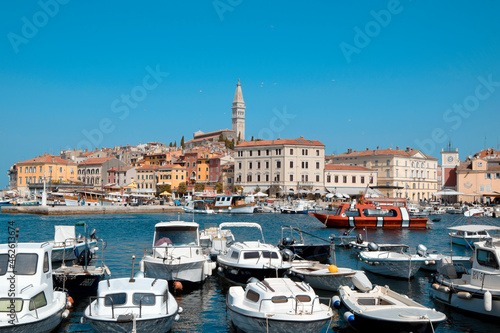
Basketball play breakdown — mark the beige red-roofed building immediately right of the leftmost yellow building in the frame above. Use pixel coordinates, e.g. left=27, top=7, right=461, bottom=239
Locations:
left=78, top=157, right=126, bottom=188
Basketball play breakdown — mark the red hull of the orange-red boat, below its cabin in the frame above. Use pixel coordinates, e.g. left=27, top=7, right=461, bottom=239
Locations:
left=309, top=213, right=428, bottom=229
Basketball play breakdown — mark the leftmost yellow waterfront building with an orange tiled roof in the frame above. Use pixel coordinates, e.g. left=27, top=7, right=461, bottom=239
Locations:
left=17, top=154, right=77, bottom=195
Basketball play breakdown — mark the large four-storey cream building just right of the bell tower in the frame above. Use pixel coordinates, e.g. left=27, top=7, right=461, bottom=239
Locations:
left=234, top=137, right=325, bottom=194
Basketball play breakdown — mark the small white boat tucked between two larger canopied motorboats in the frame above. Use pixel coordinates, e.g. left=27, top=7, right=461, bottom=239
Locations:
left=200, top=222, right=237, bottom=260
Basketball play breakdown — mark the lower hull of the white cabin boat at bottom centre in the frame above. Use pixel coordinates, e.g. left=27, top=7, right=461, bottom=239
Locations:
left=229, top=307, right=329, bottom=333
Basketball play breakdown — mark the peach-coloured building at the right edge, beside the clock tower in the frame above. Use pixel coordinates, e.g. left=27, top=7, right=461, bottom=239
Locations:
left=456, top=158, right=500, bottom=203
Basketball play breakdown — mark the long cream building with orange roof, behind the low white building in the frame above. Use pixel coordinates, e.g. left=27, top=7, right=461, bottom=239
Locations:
left=330, top=147, right=438, bottom=202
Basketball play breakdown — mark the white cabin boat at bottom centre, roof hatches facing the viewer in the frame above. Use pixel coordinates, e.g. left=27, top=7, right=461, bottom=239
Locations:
left=226, top=278, right=333, bottom=333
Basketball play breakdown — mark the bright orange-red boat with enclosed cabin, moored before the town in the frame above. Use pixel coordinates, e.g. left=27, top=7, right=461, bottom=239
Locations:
left=309, top=198, right=428, bottom=229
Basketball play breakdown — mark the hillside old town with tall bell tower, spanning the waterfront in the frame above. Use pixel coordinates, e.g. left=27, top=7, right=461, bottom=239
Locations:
left=0, top=80, right=500, bottom=204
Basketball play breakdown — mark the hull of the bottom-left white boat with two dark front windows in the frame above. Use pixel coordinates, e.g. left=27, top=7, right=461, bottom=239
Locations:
left=85, top=313, right=177, bottom=333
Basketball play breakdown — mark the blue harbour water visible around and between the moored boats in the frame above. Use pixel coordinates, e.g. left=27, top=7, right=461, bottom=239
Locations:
left=0, top=210, right=500, bottom=333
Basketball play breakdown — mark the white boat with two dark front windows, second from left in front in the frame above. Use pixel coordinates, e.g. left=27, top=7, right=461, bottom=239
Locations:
left=82, top=278, right=182, bottom=333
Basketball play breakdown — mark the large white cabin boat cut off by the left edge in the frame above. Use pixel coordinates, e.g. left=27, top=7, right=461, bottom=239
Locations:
left=0, top=242, right=69, bottom=333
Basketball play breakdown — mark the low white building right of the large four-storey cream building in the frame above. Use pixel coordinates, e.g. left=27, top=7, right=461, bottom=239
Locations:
left=324, top=164, right=382, bottom=197
